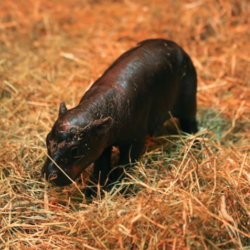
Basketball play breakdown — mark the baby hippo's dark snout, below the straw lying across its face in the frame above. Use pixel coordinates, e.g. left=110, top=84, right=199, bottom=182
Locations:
left=41, top=158, right=72, bottom=186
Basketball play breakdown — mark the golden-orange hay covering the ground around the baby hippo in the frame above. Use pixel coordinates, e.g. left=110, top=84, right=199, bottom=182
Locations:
left=0, top=0, right=250, bottom=249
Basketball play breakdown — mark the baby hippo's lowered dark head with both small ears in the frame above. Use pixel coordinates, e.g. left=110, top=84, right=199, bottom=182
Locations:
left=42, top=102, right=112, bottom=186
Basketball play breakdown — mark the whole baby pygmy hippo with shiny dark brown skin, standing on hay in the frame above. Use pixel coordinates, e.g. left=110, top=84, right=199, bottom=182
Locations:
left=42, top=39, right=197, bottom=195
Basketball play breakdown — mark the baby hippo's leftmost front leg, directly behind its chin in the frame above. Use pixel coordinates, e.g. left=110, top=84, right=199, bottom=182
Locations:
left=85, top=146, right=112, bottom=197
